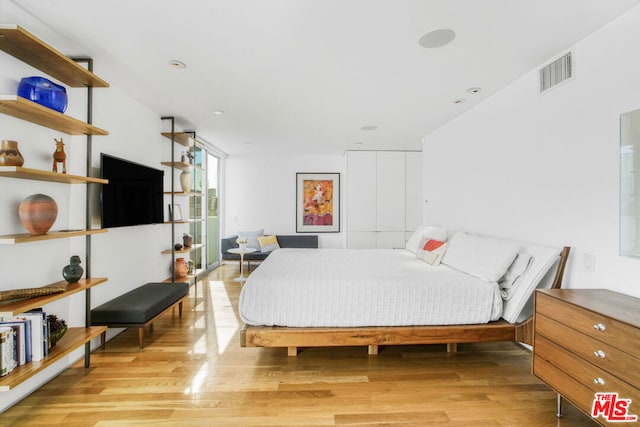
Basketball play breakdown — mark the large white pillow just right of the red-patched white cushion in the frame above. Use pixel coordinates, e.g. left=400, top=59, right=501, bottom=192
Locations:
left=442, top=232, right=518, bottom=282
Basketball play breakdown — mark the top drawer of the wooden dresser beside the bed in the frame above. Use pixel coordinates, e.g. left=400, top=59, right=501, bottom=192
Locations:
left=536, top=292, right=640, bottom=359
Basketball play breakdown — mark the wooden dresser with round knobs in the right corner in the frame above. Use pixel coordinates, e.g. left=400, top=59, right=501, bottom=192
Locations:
left=533, top=289, right=640, bottom=425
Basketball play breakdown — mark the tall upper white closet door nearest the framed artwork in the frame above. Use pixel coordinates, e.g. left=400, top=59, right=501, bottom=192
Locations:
left=346, top=151, right=376, bottom=231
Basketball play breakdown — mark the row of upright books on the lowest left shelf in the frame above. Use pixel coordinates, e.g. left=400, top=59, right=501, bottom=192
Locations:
left=0, top=309, right=51, bottom=376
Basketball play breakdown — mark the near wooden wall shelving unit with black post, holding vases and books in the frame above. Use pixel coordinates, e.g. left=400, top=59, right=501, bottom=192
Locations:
left=0, top=25, right=109, bottom=391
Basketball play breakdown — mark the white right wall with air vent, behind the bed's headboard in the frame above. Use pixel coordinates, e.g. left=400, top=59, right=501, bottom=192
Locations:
left=423, top=7, right=640, bottom=296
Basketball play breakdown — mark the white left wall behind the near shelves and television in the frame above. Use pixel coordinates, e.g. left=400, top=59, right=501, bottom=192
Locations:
left=0, top=10, right=171, bottom=412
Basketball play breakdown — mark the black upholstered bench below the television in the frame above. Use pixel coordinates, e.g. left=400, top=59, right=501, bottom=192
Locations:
left=91, top=282, right=189, bottom=349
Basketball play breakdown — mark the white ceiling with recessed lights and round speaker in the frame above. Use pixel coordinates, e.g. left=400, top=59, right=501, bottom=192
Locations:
left=0, top=0, right=640, bottom=155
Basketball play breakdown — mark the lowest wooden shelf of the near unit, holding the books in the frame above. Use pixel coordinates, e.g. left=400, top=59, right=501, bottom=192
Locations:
left=0, top=326, right=107, bottom=391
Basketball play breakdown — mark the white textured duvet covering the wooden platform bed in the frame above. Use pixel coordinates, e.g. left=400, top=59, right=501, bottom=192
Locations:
left=239, top=249, right=502, bottom=327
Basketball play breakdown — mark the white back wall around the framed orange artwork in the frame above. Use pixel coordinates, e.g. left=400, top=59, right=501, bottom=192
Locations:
left=221, top=156, right=346, bottom=248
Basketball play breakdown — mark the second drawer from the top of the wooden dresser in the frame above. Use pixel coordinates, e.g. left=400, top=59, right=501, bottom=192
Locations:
left=534, top=313, right=640, bottom=387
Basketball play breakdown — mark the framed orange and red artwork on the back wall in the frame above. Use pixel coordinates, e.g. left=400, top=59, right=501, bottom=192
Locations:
left=296, top=173, right=340, bottom=233
